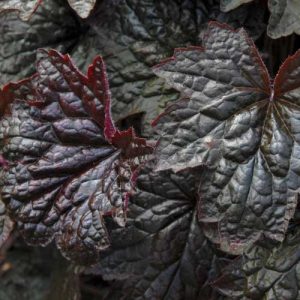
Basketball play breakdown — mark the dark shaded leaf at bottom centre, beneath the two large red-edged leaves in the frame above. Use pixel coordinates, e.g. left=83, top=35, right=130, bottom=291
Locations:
left=90, top=165, right=226, bottom=300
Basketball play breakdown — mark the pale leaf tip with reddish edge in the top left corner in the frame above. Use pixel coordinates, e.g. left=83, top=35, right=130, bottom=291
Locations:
left=0, top=0, right=42, bottom=21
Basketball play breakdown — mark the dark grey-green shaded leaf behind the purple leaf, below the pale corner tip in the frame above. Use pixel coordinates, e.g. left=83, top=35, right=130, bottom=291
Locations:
left=0, top=0, right=80, bottom=85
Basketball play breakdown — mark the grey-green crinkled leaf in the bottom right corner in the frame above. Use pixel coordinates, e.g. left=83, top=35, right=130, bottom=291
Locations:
left=215, top=229, right=300, bottom=300
